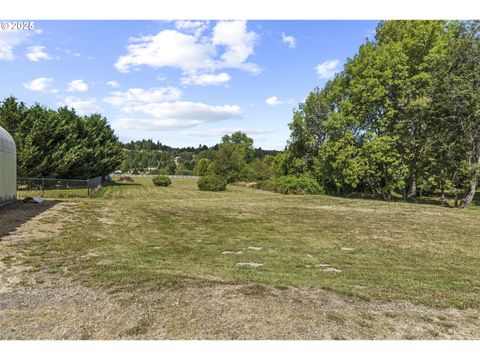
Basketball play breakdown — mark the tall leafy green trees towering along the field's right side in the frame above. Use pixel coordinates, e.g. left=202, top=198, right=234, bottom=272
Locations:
left=282, top=21, right=480, bottom=207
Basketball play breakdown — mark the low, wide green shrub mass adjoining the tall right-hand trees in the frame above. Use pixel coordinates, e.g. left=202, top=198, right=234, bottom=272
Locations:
left=256, top=175, right=325, bottom=195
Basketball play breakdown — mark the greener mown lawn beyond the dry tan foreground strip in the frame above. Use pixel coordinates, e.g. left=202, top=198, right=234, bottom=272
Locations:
left=24, top=179, right=480, bottom=308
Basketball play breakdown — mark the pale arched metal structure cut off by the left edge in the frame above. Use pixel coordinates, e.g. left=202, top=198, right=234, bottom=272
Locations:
left=0, top=126, right=17, bottom=206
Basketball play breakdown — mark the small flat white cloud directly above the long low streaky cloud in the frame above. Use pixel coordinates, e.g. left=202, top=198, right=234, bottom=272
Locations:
left=104, top=86, right=182, bottom=106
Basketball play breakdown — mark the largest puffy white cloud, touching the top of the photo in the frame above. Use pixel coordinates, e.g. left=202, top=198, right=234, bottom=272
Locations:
left=114, top=21, right=261, bottom=74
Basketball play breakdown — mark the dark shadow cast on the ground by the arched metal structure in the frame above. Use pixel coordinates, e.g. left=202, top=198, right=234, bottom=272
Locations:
left=0, top=200, right=60, bottom=241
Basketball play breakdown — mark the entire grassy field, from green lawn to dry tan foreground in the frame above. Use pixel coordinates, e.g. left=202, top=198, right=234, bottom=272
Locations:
left=0, top=180, right=480, bottom=339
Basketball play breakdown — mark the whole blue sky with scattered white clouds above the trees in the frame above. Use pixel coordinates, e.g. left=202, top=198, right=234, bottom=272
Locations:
left=0, top=20, right=377, bottom=149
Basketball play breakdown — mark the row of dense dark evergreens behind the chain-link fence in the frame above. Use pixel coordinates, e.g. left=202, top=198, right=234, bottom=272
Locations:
left=0, top=96, right=123, bottom=179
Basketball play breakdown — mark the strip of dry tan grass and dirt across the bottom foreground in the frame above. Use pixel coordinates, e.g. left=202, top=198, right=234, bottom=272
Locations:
left=0, top=277, right=480, bottom=339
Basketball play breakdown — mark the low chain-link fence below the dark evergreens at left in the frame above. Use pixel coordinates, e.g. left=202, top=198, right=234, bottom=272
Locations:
left=17, top=176, right=103, bottom=198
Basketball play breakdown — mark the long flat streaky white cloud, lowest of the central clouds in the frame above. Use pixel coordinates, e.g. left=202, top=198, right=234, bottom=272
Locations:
left=117, top=101, right=242, bottom=130
